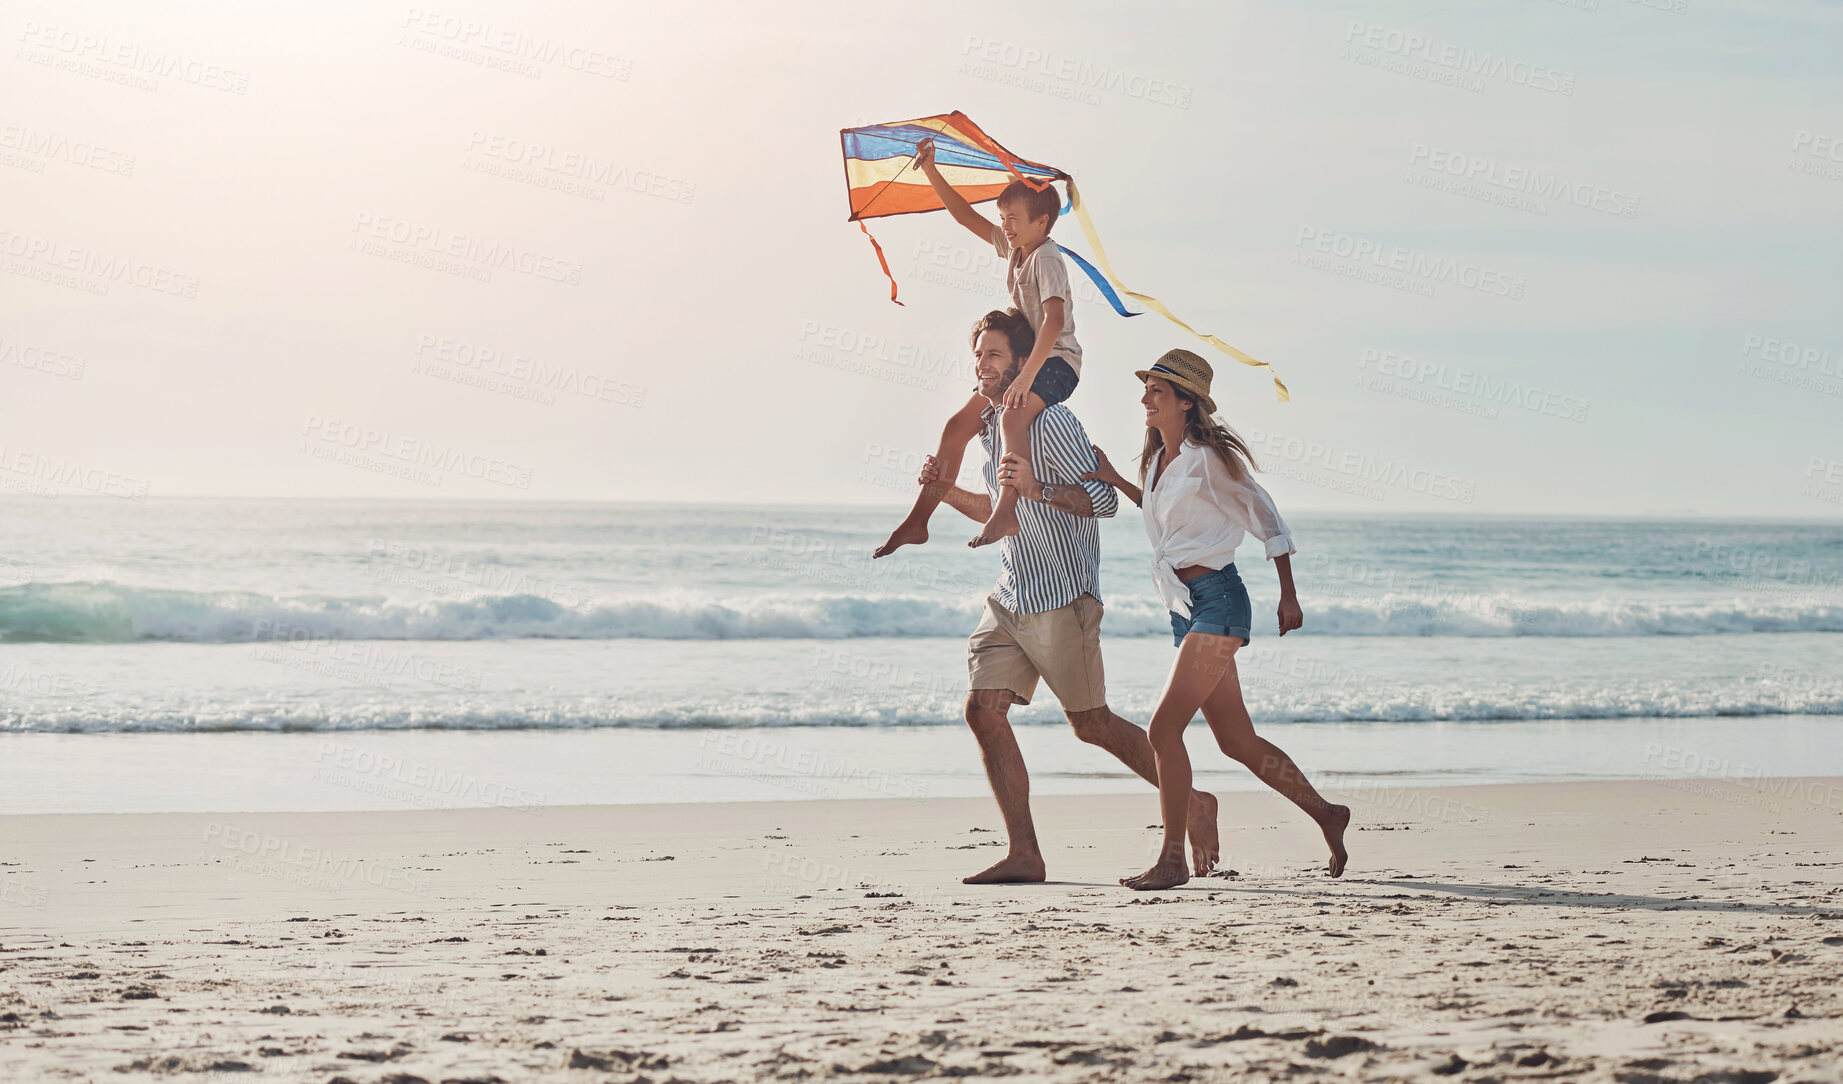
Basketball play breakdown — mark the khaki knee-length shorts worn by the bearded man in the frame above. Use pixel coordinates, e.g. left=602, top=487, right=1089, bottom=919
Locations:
left=966, top=595, right=1108, bottom=712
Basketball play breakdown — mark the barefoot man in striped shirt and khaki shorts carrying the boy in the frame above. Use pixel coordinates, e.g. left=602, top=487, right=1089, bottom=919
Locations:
left=918, top=310, right=1220, bottom=885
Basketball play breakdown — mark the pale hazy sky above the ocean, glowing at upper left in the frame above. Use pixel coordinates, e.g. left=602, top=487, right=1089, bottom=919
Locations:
left=0, top=0, right=1843, bottom=518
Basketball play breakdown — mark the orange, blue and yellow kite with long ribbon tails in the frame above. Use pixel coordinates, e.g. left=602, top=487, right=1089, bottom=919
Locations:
left=839, top=112, right=1290, bottom=402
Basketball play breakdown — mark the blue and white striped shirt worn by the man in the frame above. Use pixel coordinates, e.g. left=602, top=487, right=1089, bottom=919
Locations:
left=979, top=402, right=1121, bottom=614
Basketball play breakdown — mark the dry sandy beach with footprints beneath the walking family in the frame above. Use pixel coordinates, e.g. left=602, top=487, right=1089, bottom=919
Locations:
left=0, top=778, right=1843, bottom=1084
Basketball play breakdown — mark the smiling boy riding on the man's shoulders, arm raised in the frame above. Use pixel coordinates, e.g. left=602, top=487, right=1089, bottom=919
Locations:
left=872, top=140, right=1082, bottom=557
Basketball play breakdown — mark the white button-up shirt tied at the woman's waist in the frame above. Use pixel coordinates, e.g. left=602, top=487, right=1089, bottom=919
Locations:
left=1143, top=441, right=1296, bottom=618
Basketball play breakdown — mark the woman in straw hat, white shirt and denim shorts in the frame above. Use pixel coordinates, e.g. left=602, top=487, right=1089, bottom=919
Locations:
left=1087, top=350, right=1351, bottom=890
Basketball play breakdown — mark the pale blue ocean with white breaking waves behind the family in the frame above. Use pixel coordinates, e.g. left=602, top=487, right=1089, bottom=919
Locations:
left=0, top=500, right=1843, bottom=813
